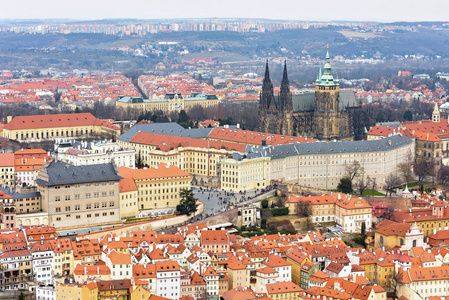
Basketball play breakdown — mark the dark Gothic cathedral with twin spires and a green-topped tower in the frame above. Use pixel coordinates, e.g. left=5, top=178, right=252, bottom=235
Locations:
left=258, top=49, right=360, bottom=141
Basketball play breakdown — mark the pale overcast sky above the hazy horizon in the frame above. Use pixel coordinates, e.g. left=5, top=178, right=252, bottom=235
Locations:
left=0, top=0, right=449, bottom=22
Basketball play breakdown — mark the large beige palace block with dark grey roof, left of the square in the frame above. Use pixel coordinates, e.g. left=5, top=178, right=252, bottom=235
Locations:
left=36, top=161, right=122, bottom=229
